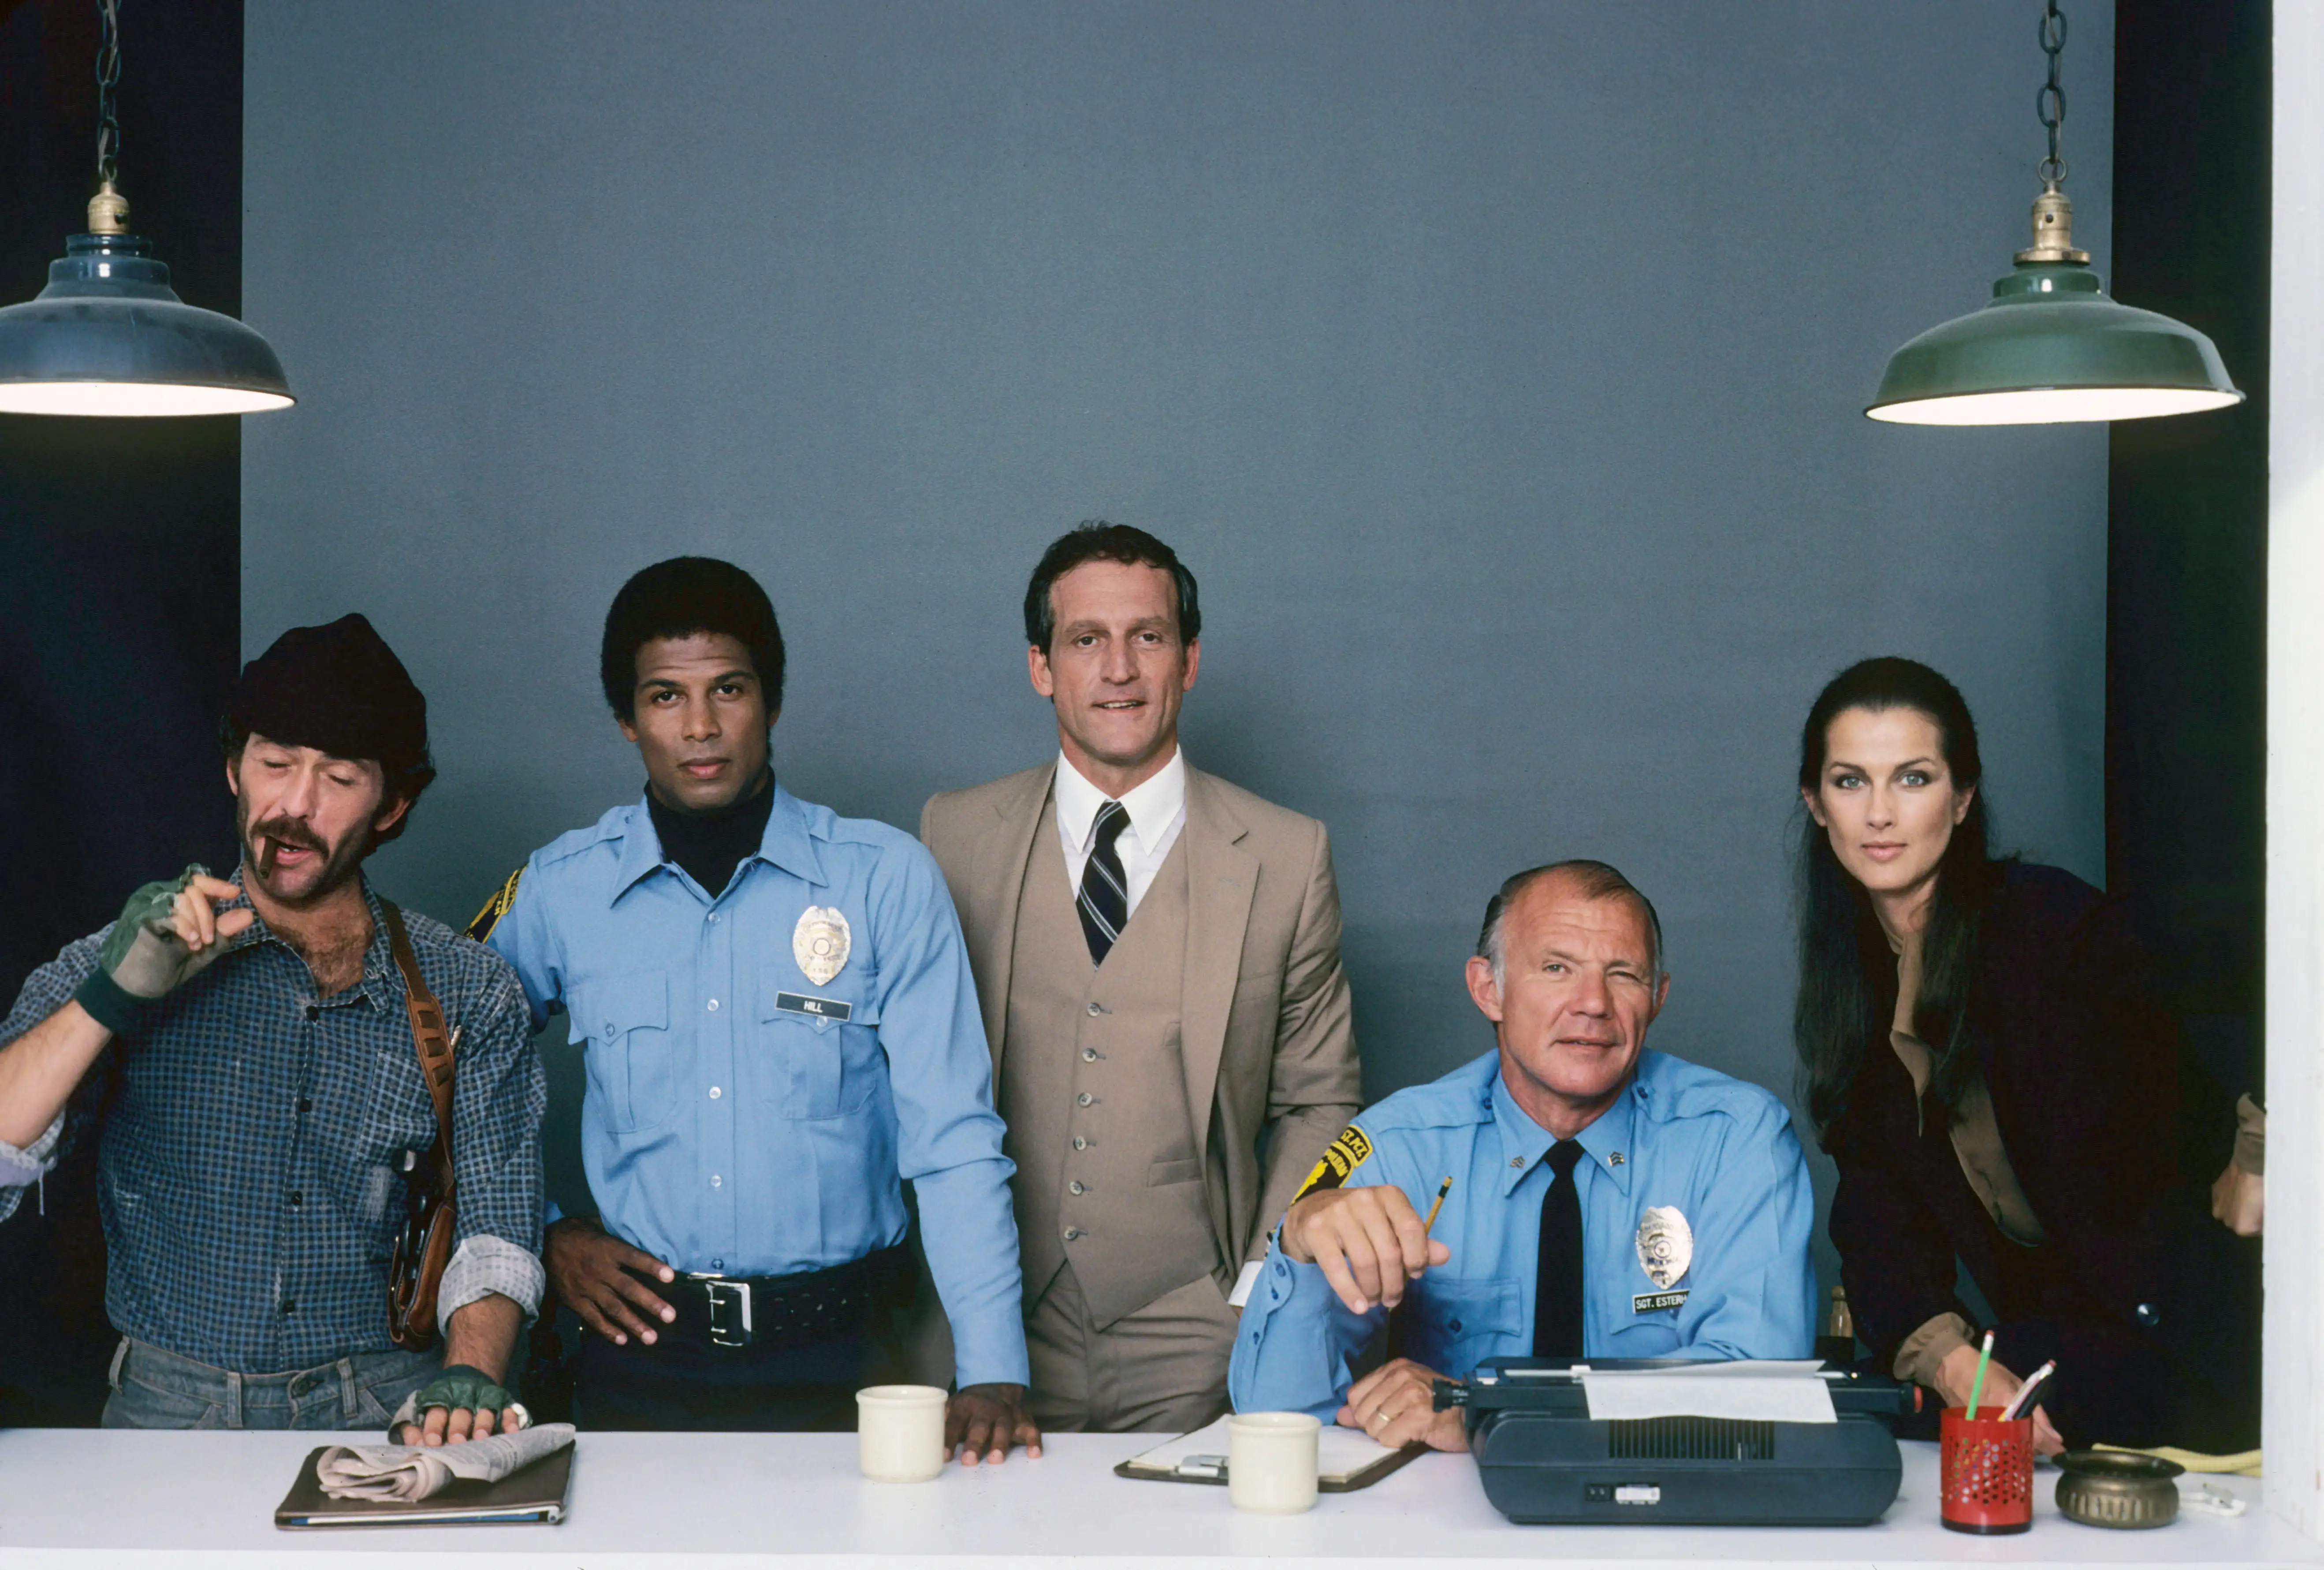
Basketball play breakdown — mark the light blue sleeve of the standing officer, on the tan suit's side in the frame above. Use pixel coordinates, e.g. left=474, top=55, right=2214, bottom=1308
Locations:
left=872, top=843, right=1029, bottom=1384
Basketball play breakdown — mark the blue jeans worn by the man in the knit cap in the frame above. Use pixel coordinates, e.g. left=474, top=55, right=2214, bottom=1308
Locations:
left=102, top=1336, right=444, bottom=1435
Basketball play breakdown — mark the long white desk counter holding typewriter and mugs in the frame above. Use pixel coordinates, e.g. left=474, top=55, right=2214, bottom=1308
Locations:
left=0, top=1429, right=2324, bottom=1570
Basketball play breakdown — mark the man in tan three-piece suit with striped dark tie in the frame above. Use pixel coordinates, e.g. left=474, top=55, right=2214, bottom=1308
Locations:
left=920, top=523, right=1362, bottom=1431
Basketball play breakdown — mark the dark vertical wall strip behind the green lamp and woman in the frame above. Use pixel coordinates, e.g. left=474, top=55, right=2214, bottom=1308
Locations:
left=2105, top=0, right=2273, bottom=1110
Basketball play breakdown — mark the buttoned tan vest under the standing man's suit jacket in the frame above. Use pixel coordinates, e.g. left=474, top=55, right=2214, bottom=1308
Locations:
left=999, top=804, right=1218, bottom=1326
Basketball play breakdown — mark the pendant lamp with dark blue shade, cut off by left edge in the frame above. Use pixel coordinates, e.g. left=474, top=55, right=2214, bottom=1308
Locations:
left=0, top=0, right=293, bottom=416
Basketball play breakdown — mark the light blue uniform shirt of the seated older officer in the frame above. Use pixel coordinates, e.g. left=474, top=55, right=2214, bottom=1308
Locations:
left=1227, top=1050, right=1815, bottom=1421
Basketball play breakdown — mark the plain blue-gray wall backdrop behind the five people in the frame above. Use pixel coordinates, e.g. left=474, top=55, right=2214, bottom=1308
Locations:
left=242, top=0, right=2112, bottom=1273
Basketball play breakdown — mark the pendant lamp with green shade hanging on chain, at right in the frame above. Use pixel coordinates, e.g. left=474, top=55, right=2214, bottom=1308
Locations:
left=1864, top=0, right=2242, bottom=425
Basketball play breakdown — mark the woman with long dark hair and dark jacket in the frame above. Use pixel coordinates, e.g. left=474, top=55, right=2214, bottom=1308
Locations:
left=1794, top=659, right=2257, bottom=1454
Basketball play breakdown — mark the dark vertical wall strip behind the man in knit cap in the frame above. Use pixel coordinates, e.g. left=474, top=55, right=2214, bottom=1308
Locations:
left=0, top=0, right=242, bottom=1424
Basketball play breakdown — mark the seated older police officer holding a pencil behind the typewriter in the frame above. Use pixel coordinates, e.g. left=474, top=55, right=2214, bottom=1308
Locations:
left=1227, top=862, right=1815, bottom=1449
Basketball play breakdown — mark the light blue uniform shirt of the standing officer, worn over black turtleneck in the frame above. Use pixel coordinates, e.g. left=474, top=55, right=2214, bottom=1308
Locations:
left=490, top=785, right=1027, bottom=1384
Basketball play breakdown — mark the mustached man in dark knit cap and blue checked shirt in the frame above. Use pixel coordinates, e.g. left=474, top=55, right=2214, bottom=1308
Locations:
left=0, top=615, right=544, bottom=1444
